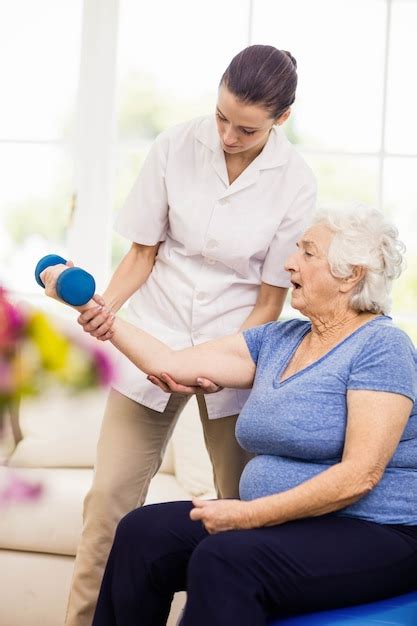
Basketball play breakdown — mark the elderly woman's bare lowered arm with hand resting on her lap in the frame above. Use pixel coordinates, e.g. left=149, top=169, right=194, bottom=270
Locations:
left=191, top=390, right=412, bottom=532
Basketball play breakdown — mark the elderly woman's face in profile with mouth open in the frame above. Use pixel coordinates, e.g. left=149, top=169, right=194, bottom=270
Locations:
left=285, top=224, right=341, bottom=317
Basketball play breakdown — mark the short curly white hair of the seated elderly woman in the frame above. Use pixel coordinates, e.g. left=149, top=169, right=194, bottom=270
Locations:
left=312, top=206, right=405, bottom=314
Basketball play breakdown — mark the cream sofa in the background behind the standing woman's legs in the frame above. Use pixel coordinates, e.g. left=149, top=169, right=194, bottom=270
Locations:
left=0, top=310, right=215, bottom=626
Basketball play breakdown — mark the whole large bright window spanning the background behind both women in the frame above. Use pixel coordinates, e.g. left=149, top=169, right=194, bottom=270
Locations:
left=0, top=0, right=417, bottom=340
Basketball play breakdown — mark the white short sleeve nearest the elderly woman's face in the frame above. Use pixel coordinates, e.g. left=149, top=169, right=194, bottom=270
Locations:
left=262, top=173, right=317, bottom=287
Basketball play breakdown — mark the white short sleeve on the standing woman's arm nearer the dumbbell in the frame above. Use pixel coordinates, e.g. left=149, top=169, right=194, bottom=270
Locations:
left=114, top=133, right=168, bottom=246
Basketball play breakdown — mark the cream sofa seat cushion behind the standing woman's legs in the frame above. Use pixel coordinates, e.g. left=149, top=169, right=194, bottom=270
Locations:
left=0, top=468, right=190, bottom=555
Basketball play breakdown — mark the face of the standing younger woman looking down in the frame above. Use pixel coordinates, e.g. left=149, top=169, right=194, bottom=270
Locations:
left=216, top=85, right=282, bottom=154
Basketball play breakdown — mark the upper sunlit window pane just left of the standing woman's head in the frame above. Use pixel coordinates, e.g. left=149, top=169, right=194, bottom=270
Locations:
left=117, top=0, right=249, bottom=139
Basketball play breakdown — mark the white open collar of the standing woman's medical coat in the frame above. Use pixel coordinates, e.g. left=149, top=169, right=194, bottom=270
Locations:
left=195, top=115, right=291, bottom=197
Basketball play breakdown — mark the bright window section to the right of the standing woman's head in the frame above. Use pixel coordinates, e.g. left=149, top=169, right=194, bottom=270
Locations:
left=251, top=0, right=417, bottom=340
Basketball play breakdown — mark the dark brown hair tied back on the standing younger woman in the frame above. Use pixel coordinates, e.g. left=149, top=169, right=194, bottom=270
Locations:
left=220, top=45, right=297, bottom=119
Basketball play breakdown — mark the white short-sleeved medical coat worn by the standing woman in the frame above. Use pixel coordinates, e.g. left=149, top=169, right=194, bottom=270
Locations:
left=114, top=115, right=316, bottom=419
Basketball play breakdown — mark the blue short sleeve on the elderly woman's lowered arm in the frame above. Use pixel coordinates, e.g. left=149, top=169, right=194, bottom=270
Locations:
left=347, top=326, right=417, bottom=402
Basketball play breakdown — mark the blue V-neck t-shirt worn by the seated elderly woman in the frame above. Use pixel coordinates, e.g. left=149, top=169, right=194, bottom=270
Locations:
left=236, top=316, right=417, bottom=525
